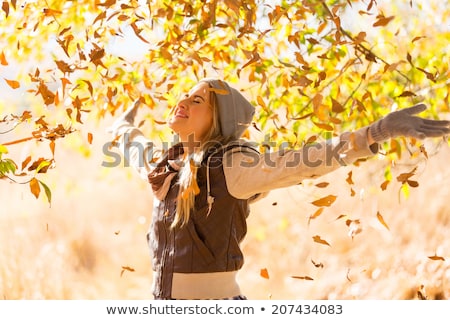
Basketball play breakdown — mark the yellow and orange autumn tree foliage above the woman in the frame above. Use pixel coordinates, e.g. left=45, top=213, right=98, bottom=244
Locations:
left=0, top=0, right=450, bottom=201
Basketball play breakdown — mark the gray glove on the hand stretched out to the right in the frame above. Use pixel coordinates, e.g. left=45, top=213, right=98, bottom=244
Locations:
left=369, top=103, right=450, bottom=142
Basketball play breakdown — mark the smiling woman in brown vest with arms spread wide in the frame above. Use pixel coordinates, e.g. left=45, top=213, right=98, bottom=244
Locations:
left=108, top=79, right=450, bottom=299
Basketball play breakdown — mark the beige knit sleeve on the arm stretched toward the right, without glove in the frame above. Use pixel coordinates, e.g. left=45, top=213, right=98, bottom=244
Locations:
left=224, top=128, right=378, bottom=199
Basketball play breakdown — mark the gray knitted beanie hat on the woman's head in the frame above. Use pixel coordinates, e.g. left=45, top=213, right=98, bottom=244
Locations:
left=201, top=78, right=255, bottom=139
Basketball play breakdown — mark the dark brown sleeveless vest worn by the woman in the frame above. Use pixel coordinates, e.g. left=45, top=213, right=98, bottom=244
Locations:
left=147, top=145, right=256, bottom=299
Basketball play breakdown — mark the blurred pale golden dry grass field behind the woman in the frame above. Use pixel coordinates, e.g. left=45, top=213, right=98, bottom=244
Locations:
left=0, top=118, right=450, bottom=300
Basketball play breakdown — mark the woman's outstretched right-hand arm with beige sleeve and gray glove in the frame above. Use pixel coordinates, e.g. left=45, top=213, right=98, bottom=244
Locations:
left=224, top=104, right=450, bottom=199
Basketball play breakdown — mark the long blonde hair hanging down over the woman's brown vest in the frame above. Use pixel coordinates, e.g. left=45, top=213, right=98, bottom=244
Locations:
left=172, top=85, right=227, bottom=228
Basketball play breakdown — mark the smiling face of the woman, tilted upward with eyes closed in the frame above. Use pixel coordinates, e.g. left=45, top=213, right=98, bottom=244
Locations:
left=168, top=82, right=213, bottom=142
